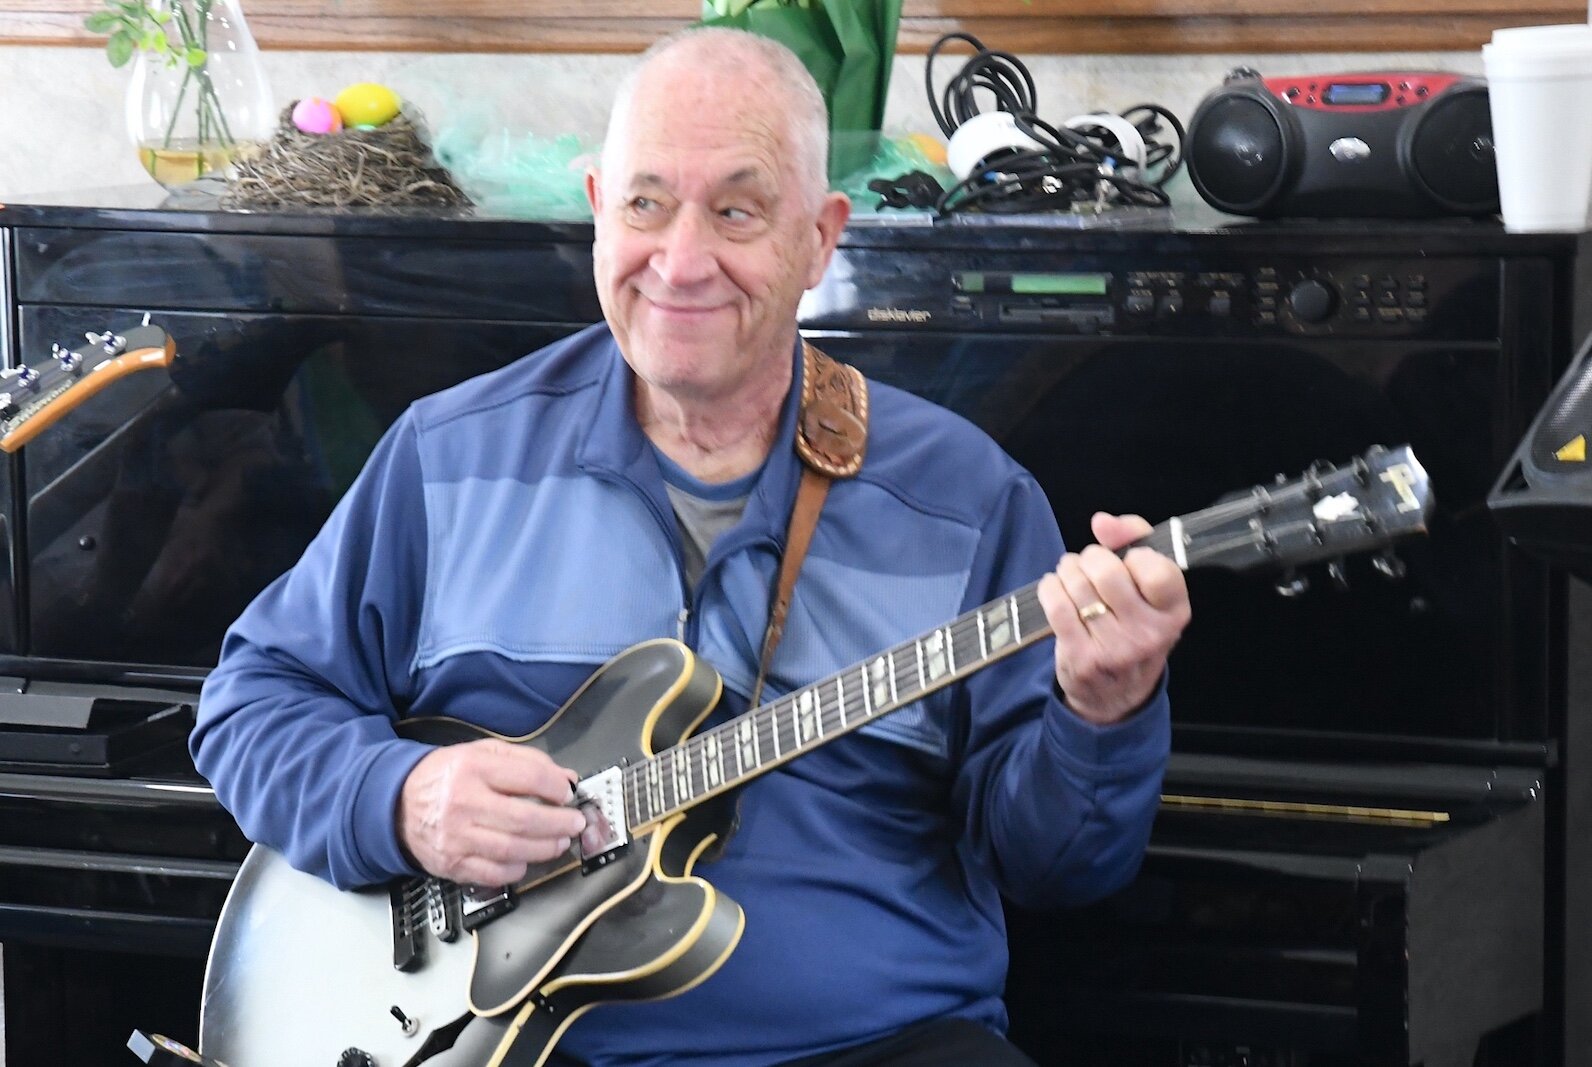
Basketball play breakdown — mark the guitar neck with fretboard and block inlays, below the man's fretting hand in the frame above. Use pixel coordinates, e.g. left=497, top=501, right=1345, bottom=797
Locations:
left=624, top=519, right=1188, bottom=827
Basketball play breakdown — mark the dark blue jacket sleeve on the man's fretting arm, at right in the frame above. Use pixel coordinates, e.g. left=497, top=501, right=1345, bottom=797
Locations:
left=952, top=475, right=1172, bottom=908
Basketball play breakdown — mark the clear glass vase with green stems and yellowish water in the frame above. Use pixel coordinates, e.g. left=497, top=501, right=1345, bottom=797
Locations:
left=127, top=0, right=277, bottom=188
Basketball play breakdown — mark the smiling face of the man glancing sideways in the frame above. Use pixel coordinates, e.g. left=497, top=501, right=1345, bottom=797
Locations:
left=586, top=61, right=849, bottom=400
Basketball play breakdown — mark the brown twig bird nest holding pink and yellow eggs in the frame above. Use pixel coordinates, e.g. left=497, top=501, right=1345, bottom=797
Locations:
left=221, top=102, right=470, bottom=207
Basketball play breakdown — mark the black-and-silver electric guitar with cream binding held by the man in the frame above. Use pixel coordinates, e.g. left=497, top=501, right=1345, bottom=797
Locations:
left=201, top=448, right=1431, bottom=1067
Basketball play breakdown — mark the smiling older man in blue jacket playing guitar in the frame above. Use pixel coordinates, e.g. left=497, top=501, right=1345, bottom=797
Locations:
left=193, top=30, right=1189, bottom=1065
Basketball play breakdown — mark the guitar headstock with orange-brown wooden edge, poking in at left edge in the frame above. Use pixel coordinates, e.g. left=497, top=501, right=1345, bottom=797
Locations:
left=0, top=322, right=177, bottom=452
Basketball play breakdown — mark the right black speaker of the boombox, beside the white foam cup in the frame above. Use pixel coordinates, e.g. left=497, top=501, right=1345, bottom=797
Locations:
left=1409, top=86, right=1498, bottom=215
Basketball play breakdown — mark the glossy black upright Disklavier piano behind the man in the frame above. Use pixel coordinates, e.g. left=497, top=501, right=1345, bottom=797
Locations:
left=0, top=186, right=1592, bottom=1067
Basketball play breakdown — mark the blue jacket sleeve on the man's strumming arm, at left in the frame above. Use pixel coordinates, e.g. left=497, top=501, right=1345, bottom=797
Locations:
left=189, top=416, right=428, bottom=889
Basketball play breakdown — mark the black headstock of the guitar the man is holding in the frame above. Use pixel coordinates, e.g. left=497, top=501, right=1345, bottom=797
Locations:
left=1153, top=446, right=1433, bottom=570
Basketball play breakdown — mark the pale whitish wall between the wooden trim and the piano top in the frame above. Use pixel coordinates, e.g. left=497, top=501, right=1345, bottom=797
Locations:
left=0, top=46, right=1481, bottom=208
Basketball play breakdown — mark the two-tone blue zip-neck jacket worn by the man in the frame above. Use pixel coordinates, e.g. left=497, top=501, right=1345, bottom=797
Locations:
left=193, top=326, right=1170, bottom=1067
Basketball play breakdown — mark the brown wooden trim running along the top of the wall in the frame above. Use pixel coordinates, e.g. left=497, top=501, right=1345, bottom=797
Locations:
left=0, top=0, right=1586, bottom=54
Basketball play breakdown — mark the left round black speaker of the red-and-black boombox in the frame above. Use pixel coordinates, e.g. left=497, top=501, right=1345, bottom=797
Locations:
left=1189, top=96, right=1285, bottom=212
